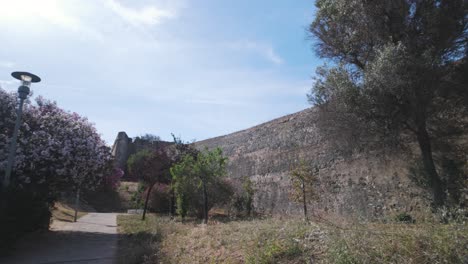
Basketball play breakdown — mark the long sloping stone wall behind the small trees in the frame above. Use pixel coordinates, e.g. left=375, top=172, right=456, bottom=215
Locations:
left=195, top=109, right=428, bottom=219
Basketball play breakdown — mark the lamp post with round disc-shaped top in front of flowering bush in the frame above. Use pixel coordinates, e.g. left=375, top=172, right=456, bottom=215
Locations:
left=3, top=72, right=41, bottom=189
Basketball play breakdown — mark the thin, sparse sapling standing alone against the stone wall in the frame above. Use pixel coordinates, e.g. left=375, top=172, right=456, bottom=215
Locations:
left=289, top=160, right=318, bottom=221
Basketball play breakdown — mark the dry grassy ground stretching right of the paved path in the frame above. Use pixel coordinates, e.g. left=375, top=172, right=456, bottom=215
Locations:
left=117, top=214, right=468, bottom=263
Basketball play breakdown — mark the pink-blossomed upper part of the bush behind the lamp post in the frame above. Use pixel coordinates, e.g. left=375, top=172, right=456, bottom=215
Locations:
left=0, top=91, right=111, bottom=191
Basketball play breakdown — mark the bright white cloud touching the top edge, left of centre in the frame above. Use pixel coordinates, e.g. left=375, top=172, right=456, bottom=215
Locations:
left=105, top=0, right=176, bottom=26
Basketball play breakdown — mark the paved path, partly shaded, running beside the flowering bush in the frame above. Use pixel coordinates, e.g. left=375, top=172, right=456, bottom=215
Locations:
left=0, top=213, right=118, bottom=264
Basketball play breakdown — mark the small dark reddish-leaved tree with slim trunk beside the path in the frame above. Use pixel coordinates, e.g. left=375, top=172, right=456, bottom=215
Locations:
left=127, top=149, right=172, bottom=220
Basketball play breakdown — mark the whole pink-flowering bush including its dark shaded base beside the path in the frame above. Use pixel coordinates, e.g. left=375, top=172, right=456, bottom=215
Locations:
left=0, top=88, right=116, bottom=241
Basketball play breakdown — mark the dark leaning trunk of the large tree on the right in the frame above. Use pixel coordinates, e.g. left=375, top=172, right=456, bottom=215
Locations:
left=416, top=125, right=444, bottom=207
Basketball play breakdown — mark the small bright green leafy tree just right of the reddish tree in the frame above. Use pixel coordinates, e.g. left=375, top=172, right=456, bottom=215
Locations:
left=171, top=148, right=230, bottom=224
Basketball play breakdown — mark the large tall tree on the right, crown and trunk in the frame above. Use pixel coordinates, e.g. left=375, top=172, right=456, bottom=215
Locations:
left=308, top=0, right=468, bottom=206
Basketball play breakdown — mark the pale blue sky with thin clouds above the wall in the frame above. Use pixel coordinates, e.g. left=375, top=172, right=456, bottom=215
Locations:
left=0, top=0, right=322, bottom=144
